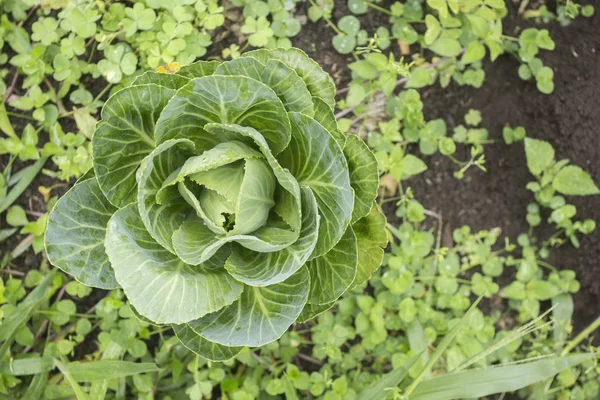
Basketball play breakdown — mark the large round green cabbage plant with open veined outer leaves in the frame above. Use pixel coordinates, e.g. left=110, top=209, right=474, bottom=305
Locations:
left=45, top=49, right=386, bottom=360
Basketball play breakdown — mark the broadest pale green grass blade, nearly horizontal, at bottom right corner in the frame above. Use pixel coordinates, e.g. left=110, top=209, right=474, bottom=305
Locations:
left=409, top=354, right=593, bottom=400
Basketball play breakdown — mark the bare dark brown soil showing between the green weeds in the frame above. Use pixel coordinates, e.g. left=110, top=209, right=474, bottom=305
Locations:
left=0, top=1, right=600, bottom=339
